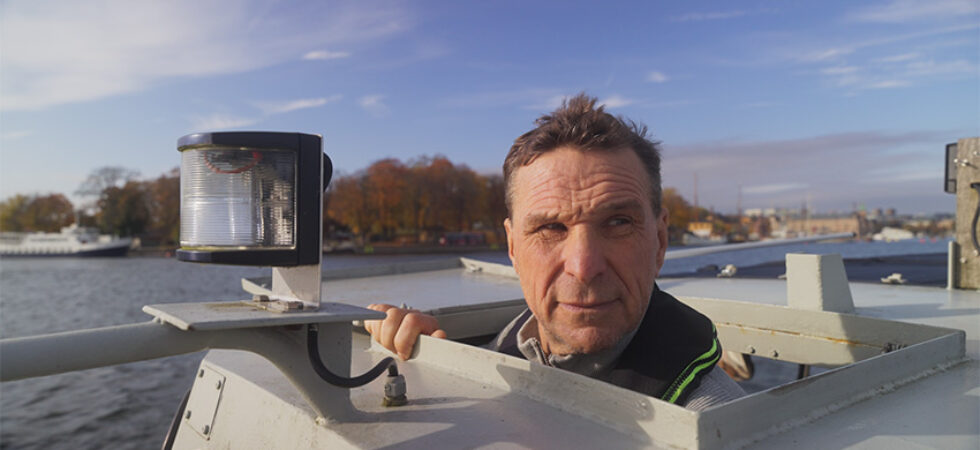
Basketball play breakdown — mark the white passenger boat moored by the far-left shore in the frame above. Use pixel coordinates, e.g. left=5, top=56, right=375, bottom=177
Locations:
left=0, top=224, right=133, bottom=256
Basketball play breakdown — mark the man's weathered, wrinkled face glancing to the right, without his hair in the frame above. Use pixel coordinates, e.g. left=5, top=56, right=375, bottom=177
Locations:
left=504, top=148, right=667, bottom=355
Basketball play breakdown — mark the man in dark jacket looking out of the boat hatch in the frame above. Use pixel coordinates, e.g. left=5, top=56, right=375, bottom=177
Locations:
left=366, top=94, right=743, bottom=410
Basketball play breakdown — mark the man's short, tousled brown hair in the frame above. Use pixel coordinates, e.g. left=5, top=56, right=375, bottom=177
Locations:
left=504, top=93, right=661, bottom=217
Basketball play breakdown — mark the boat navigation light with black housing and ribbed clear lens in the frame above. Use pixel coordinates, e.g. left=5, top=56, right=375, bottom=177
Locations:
left=177, top=132, right=332, bottom=267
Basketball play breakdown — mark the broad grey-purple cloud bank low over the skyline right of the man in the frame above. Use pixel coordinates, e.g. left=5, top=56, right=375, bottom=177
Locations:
left=663, top=130, right=949, bottom=210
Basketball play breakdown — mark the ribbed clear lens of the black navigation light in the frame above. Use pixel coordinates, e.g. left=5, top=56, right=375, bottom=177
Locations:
left=180, top=147, right=296, bottom=248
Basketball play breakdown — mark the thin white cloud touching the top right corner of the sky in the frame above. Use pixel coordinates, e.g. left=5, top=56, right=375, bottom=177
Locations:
left=845, top=0, right=980, bottom=23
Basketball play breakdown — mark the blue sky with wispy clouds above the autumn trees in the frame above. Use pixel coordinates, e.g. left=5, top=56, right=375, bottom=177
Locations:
left=0, top=0, right=980, bottom=214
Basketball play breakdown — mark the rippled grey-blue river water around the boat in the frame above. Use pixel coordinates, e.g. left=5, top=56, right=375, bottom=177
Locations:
left=0, top=241, right=946, bottom=449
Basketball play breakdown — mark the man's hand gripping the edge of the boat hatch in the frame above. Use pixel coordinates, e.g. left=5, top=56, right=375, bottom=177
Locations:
left=364, top=303, right=446, bottom=361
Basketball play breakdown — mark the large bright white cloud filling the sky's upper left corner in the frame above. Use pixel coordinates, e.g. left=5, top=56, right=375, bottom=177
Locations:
left=0, top=0, right=414, bottom=110
